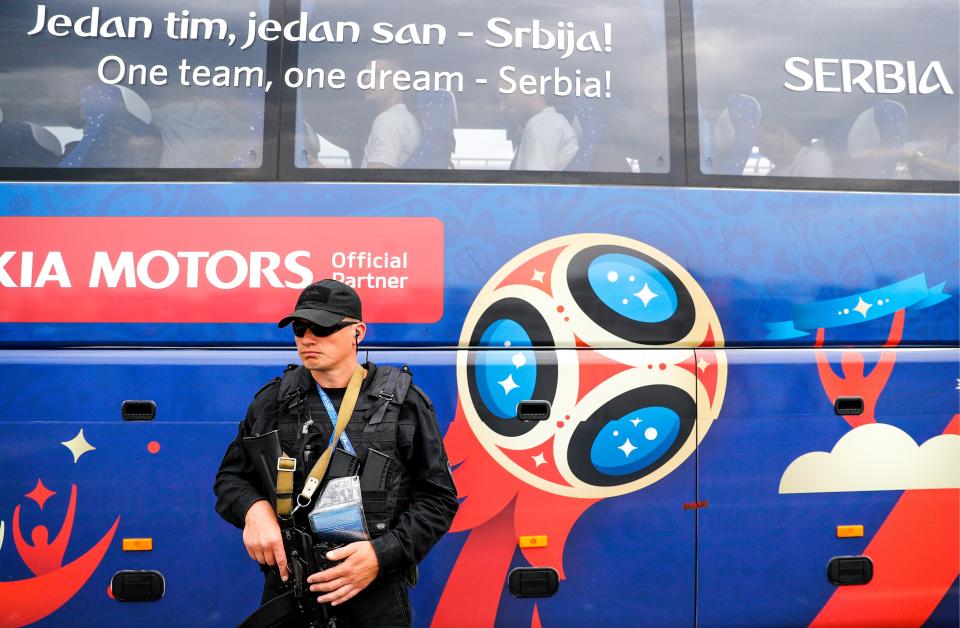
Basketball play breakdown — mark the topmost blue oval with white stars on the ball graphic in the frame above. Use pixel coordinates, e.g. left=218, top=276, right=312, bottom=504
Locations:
left=587, top=253, right=677, bottom=323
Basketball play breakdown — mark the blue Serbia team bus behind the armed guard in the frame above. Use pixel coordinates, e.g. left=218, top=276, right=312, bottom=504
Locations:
left=0, top=0, right=960, bottom=627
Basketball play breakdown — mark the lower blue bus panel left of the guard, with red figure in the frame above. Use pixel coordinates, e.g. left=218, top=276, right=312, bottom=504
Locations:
left=0, top=351, right=295, bottom=626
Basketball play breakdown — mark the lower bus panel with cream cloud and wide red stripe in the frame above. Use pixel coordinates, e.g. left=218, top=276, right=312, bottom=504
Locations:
left=697, top=348, right=960, bottom=626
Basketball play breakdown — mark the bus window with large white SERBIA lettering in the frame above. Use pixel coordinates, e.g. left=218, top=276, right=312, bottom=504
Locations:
left=693, top=0, right=960, bottom=181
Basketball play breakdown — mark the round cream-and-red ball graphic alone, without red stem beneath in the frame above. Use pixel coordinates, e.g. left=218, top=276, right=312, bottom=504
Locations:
left=457, top=234, right=726, bottom=499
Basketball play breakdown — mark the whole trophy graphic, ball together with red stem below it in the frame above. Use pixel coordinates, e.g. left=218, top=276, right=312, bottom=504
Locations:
left=433, top=234, right=727, bottom=626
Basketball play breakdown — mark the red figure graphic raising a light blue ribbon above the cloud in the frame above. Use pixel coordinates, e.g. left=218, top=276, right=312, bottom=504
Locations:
left=814, top=310, right=904, bottom=427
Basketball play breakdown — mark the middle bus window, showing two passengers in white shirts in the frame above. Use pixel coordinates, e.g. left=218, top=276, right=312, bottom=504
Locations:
left=287, top=0, right=670, bottom=173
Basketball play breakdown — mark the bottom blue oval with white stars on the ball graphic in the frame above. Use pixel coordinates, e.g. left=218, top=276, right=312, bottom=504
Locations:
left=590, top=406, right=680, bottom=475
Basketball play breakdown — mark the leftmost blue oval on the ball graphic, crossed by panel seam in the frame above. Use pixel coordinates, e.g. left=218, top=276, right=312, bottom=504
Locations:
left=476, top=319, right=537, bottom=419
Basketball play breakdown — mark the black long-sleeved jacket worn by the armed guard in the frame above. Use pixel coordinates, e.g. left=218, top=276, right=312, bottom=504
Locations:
left=213, top=363, right=459, bottom=575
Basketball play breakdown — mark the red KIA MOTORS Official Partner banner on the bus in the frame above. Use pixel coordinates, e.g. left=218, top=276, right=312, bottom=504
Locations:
left=0, top=217, right=443, bottom=323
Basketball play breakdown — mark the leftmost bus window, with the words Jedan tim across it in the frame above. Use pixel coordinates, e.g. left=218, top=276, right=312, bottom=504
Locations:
left=0, top=0, right=268, bottom=168
